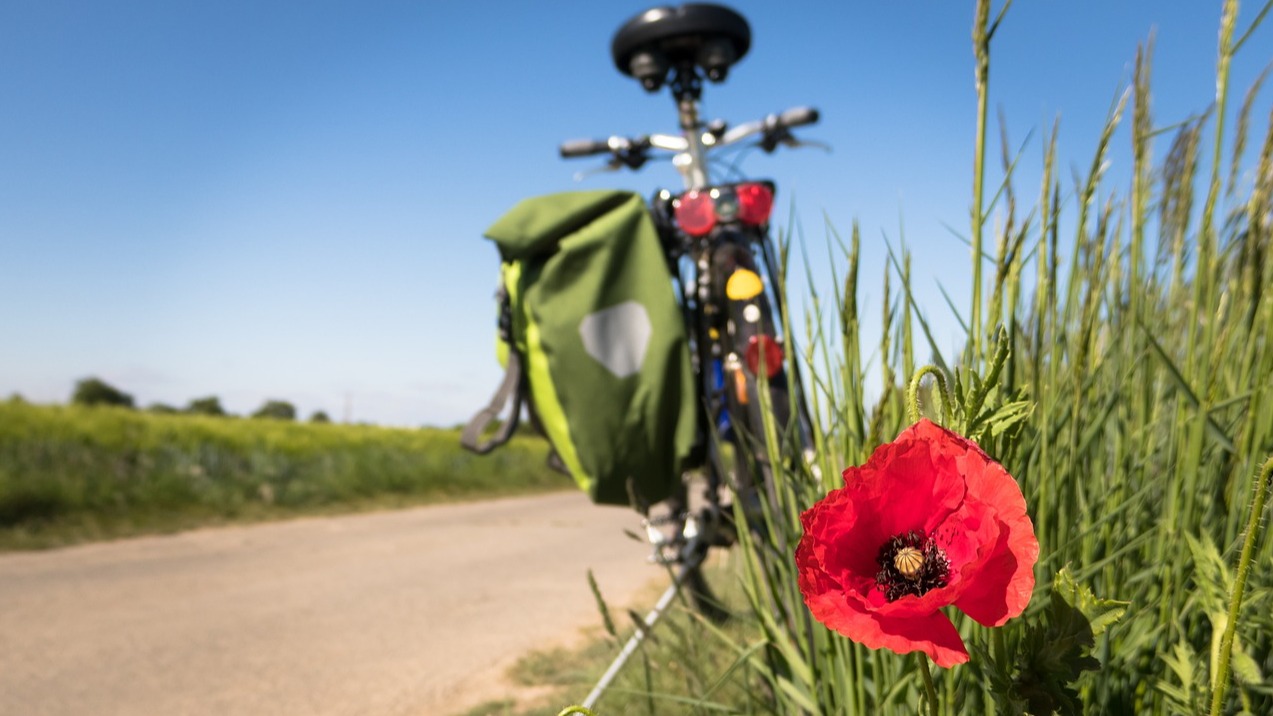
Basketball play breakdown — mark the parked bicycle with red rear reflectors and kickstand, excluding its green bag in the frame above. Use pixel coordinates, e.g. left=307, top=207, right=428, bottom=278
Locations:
left=560, top=4, right=819, bottom=706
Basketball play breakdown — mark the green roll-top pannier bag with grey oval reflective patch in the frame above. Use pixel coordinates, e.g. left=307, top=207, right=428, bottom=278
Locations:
left=462, top=191, right=698, bottom=508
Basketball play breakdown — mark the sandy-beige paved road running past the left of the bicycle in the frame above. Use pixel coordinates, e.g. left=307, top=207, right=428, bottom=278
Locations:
left=0, top=493, right=659, bottom=716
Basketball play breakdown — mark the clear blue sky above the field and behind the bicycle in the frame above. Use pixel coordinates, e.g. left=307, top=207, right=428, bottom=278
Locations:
left=0, top=0, right=1273, bottom=426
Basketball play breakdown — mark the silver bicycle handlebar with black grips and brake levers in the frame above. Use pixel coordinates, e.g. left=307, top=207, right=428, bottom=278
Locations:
left=560, top=107, right=819, bottom=161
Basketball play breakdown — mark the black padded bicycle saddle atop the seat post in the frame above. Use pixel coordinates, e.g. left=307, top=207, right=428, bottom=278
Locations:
left=610, top=3, right=751, bottom=92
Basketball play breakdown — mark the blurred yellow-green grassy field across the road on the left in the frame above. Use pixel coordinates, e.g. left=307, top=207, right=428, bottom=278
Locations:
left=0, top=401, right=572, bottom=549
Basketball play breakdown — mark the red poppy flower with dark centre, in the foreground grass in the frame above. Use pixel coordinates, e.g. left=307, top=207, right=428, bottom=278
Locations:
left=796, top=420, right=1039, bottom=668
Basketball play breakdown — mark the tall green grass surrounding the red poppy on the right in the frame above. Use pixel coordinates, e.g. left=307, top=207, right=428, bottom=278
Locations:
left=598, top=0, right=1273, bottom=713
